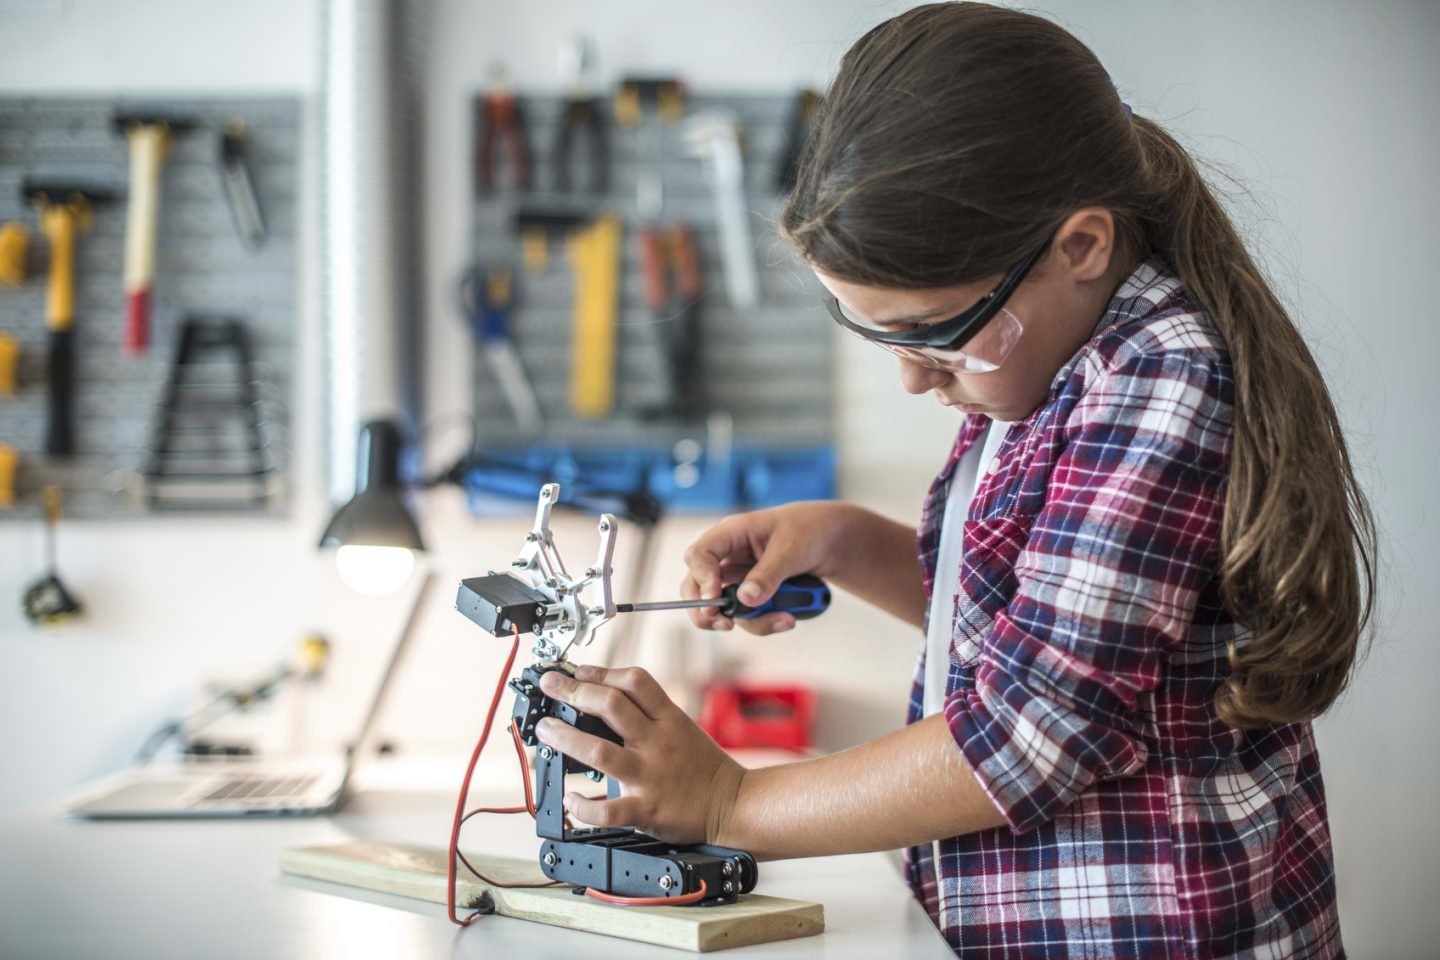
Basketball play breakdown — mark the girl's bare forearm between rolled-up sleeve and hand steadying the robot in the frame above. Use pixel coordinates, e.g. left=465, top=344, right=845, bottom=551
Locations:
left=708, top=715, right=1005, bottom=859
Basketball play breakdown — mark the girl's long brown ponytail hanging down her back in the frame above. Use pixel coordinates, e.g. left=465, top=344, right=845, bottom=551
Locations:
left=1132, top=117, right=1377, bottom=727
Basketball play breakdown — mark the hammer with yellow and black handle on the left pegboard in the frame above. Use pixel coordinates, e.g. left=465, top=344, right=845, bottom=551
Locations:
left=20, top=180, right=114, bottom=456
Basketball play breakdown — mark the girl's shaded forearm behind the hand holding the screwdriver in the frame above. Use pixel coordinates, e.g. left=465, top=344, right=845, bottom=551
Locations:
left=832, top=504, right=924, bottom=626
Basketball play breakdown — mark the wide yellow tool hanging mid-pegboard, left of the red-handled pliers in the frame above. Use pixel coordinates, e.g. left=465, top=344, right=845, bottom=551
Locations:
left=569, top=214, right=622, bottom=419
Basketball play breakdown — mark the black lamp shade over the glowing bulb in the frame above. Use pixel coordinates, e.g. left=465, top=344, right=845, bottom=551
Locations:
left=320, top=420, right=425, bottom=551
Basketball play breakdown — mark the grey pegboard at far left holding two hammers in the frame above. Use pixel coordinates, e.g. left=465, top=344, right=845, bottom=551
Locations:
left=0, top=98, right=300, bottom=520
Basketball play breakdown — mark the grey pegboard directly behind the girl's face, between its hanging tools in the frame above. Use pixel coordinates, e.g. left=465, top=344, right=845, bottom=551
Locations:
left=466, top=94, right=834, bottom=457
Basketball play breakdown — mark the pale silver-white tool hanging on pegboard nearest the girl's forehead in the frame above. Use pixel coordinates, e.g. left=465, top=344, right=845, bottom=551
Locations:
left=685, top=111, right=760, bottom=308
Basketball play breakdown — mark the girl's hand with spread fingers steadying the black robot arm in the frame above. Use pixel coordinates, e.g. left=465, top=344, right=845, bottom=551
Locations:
left=536, top=666, right=744, bottom=843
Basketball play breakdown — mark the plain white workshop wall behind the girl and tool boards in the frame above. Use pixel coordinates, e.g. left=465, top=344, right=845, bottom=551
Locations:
left=0, top=0, right=1440, bottom=957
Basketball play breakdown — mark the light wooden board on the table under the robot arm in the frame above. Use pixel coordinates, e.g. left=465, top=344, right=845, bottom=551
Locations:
left=279, top=843, right=825, bottom=953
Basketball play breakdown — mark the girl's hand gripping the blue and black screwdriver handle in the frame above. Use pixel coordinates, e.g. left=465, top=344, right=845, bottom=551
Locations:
left=680, top=501, right=852, bottom=636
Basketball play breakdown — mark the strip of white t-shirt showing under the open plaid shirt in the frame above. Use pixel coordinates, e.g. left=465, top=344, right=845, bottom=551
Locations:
left=924, top=420, right=1009, bottom=717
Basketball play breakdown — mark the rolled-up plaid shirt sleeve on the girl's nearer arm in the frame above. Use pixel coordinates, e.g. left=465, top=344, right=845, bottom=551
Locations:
left=945, top=350, right=1233, bottom=832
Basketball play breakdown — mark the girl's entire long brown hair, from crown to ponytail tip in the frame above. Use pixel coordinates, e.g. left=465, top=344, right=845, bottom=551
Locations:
left=780, top=3, right=1377, bottom=727
